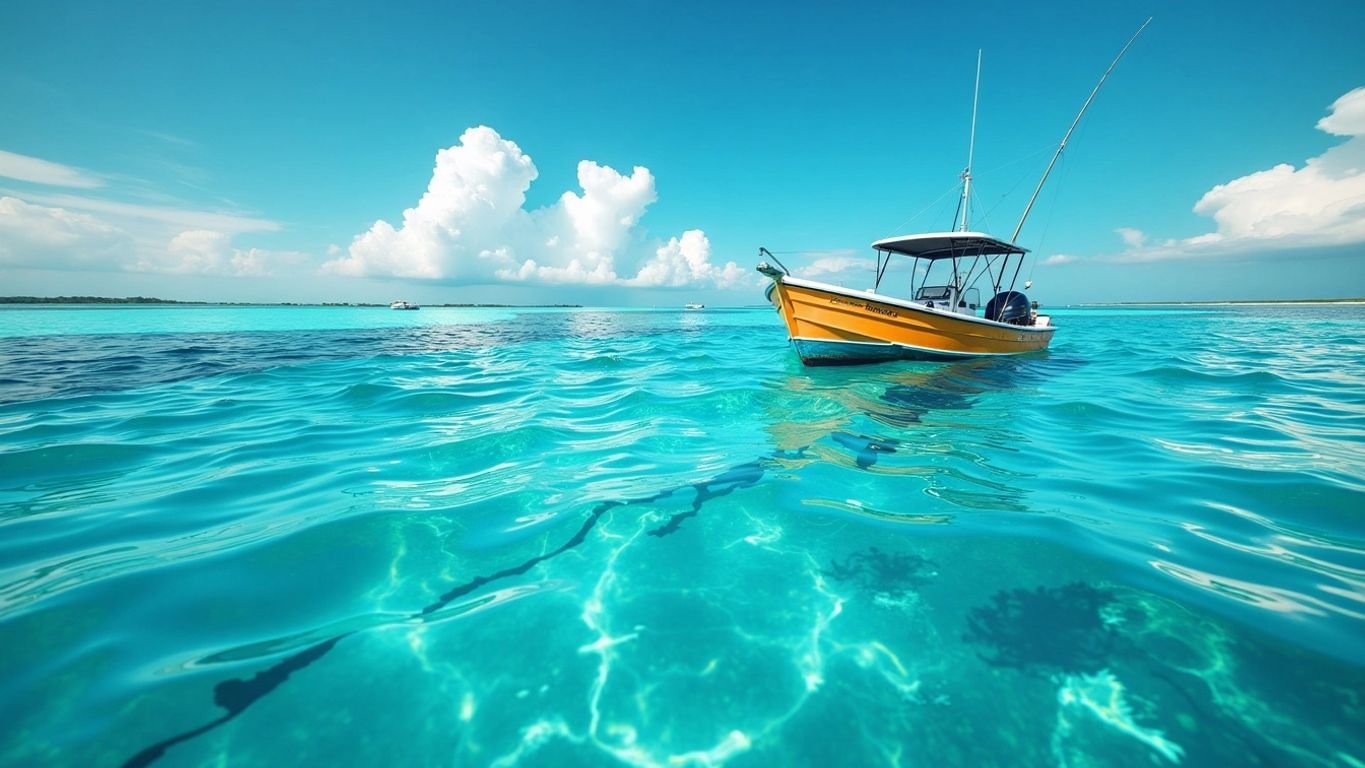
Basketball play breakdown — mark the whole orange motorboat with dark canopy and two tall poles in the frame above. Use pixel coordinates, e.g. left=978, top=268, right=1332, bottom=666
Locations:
left=756, top=19, right=1152, bottom=366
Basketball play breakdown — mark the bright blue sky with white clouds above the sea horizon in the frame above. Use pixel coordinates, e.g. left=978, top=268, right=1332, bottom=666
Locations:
left=0, top=0, right=1365, bottom=306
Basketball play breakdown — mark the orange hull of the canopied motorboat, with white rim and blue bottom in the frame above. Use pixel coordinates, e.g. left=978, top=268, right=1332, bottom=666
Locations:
left=768, top=277, right=1055, bottom=366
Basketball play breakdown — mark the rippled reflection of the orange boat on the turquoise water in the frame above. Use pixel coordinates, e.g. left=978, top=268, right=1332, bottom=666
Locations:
left=768, top=353, right=1084, bottom=524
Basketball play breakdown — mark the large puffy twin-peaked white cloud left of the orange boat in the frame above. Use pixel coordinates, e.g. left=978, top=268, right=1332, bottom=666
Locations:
left=322, top=125, right=743, bottom=288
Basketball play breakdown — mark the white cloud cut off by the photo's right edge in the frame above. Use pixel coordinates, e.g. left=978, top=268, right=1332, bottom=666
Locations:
left=1118, top=87, right=1365, bottom=261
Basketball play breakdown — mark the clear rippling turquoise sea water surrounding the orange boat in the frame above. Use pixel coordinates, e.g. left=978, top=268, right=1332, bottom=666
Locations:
left=0, top=307, right=1365, bottom=767
